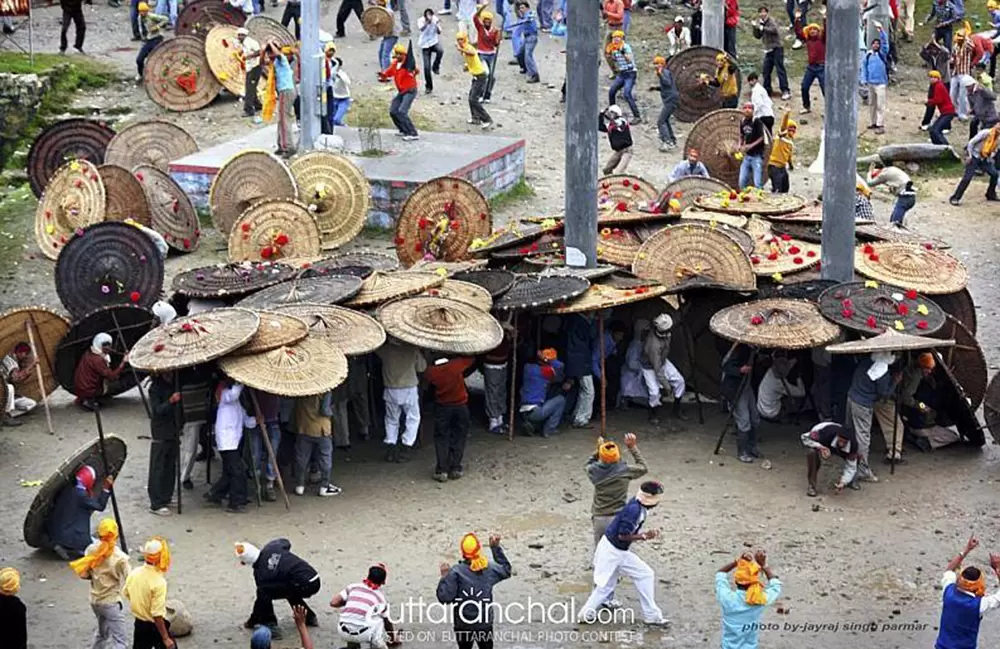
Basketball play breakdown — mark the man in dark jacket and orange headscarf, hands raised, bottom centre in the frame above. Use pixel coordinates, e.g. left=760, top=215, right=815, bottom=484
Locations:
left=437, top=533, right=511, bottom=649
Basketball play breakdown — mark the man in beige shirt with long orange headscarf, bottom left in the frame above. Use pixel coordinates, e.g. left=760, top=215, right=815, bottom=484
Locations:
left=69, top=518, right=129, bottom=649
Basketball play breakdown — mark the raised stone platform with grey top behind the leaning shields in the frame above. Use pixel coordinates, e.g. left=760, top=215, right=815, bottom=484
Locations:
left=170, top=126, right=525, bottom=228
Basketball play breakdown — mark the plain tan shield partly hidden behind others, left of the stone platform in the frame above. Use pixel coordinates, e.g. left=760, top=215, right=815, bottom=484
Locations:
left=104, top=119, right=198, bottom=173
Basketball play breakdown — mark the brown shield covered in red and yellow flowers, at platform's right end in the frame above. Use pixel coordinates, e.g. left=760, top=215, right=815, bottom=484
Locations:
left=395, top=177, right=493, bottom=268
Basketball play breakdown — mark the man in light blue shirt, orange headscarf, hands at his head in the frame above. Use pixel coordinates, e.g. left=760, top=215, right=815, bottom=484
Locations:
left=715, top=550, right=781, bottom=649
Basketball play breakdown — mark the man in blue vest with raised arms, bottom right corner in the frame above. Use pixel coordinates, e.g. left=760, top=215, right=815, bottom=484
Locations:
left=934, top=536, right=1000, bottom=649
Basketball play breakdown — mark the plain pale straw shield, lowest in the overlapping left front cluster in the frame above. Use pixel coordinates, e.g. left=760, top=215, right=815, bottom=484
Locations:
left=219, top=338, right=347, bottom=397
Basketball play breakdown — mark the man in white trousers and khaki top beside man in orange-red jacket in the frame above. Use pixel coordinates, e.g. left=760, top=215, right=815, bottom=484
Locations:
left=375, top=337, right=427, bottom=462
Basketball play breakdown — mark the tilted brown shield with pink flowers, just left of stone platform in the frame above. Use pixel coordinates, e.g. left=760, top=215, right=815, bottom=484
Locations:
left=132, top=165, right=201, bottom=252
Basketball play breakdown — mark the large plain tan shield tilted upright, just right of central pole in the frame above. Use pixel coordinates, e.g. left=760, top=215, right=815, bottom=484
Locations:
left=632, top=223, right=757, bottom=291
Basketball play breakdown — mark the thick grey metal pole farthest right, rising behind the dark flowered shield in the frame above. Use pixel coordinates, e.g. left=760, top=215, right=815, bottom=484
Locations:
left=822, top=0, right=860, bottom=282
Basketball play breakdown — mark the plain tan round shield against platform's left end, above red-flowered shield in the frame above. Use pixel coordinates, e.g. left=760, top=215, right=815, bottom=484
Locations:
left=208, top=150, right=298, bottom=237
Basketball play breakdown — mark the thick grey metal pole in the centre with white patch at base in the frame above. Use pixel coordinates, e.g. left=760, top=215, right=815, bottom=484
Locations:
left=565, top=0, right=604, bottom=268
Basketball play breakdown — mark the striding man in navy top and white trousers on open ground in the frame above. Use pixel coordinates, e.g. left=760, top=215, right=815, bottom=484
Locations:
left=580, top=481, right=670, bottom=625
